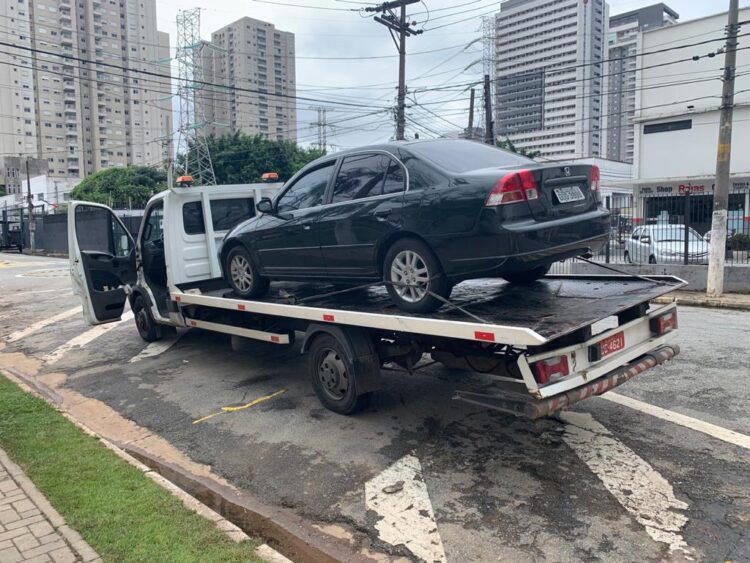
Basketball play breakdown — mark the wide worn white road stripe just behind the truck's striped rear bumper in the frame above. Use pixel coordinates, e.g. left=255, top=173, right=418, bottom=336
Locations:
left=560, top=412, right=694, bottom=558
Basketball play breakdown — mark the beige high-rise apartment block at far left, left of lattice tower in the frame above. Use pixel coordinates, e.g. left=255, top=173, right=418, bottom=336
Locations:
left=0, top=0, right=171, bottom=181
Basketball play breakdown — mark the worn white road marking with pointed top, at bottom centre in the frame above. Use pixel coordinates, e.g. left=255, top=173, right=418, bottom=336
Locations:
left=365, top=455, right=446, bottom=563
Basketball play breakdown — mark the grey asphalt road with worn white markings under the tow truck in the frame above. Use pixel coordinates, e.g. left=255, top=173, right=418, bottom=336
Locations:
left=0, top=254, right=750, bottom=562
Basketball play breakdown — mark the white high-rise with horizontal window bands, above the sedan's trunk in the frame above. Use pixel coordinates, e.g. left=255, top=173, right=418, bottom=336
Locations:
left=495, top=0, right=609, bottom=159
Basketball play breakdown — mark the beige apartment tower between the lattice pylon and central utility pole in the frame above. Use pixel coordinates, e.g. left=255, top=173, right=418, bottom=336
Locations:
left=196, top=18, right=297, bottom=140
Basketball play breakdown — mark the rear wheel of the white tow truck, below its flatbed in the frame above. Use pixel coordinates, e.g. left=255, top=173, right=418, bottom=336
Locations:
left=307, top=334, right=372, bottom=414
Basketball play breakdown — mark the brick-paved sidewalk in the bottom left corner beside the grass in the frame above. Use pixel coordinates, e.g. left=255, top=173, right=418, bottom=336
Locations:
left=0, top=450, right=101, bottom=563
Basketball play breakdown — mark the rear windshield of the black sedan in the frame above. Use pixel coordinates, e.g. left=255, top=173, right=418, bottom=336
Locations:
left=408, top=140, right=534, bottom=173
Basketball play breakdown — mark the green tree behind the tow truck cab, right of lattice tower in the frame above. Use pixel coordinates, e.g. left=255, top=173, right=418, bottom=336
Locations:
left=177, top=131, right=325, bottom=184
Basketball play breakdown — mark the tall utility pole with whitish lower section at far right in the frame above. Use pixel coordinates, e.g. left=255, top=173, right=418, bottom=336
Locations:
left=706, top=0, right=739, bottom=297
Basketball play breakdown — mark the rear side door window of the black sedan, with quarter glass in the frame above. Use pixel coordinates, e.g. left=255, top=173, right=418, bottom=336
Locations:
left=332, top=154, right=406, bottom=203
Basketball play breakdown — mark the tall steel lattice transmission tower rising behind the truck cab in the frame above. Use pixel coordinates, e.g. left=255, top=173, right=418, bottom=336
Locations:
left=176, top=8, right=216, bottom=186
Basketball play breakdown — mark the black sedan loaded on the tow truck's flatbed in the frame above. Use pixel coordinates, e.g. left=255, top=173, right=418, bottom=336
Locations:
left=221, top=140, right=609, bottom=312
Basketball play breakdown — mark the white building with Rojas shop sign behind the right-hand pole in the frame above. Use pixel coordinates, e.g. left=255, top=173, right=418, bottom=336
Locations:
left=634, top=8, right=750, bottom=234
